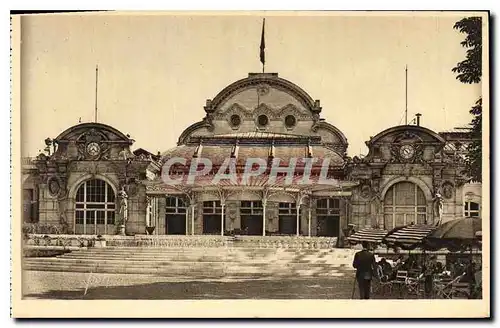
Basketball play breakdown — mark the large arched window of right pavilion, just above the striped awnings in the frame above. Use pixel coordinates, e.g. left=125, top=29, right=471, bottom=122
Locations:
left=384, top=182, right=428, bottom=229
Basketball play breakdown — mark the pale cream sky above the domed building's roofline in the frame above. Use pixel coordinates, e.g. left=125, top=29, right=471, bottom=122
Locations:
left=21, top=12, right=481, bottom=156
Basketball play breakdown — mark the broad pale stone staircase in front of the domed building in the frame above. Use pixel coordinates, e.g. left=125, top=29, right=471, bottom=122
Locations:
left=23, top=247, right=355, bottom=278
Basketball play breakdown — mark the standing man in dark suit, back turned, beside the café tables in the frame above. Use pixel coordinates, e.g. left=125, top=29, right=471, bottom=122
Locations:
left=352, top=241, right=377, bottom=299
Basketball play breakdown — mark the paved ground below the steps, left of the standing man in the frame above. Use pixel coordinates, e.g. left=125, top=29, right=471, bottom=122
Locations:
left=23, top=271, right=362, bottom=299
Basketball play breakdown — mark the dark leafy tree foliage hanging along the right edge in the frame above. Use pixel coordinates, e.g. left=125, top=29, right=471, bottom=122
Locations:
left=452, top=17, right=483, bottom=181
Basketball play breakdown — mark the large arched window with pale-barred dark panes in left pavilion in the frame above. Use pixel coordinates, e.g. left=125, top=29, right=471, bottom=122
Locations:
left=75, top=179, right=116, bottom=235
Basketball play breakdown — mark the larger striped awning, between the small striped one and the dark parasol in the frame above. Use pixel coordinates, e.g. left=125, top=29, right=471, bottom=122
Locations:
left=383, top=225, right=436, bottom=249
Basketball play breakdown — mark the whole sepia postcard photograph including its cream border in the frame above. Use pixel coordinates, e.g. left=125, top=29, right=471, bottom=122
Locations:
left=11, top=11, right=491, bottom=318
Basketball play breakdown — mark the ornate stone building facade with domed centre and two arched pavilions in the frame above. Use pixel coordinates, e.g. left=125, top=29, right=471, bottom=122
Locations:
left=23, top=73, right=481, bottom=241
